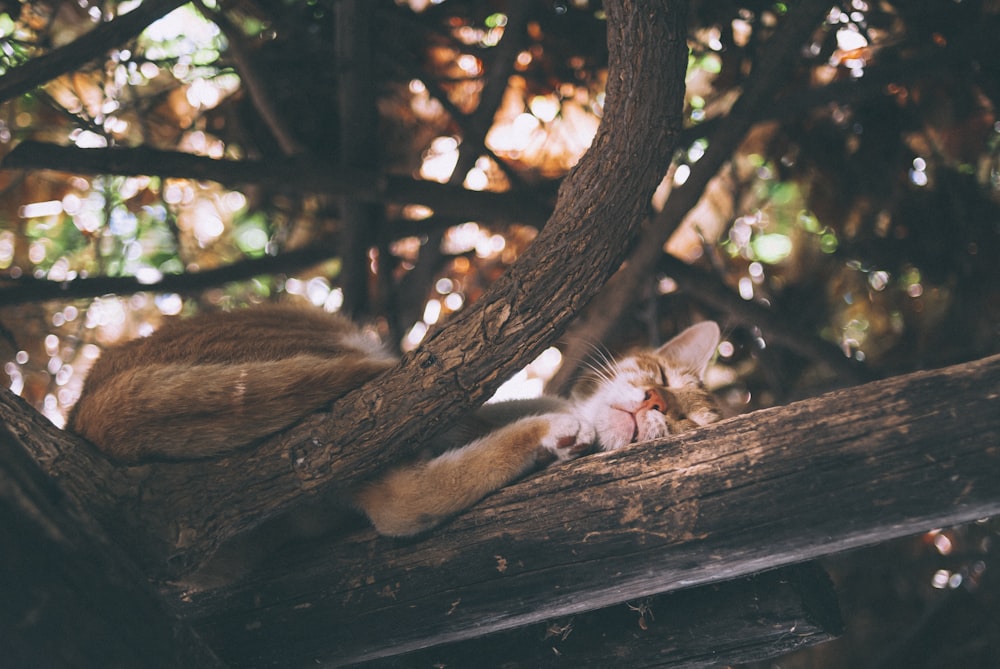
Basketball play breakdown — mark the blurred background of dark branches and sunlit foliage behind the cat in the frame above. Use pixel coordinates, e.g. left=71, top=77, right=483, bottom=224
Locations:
left=0, top=0, right=1000, bottom=667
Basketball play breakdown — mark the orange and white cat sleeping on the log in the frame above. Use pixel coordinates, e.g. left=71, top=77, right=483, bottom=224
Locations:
left=69, top=306, right=719, bottom=536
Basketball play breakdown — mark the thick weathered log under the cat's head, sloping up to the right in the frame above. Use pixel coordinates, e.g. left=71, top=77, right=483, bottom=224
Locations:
left=187, top=357, right=1000, bottom=666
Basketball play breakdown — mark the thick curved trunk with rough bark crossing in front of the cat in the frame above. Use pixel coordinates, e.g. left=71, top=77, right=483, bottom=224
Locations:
left=5, top=0, right=687, bottom=576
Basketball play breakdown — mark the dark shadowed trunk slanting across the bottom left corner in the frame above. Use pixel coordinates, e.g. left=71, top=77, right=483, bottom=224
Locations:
left=0, top=426, right=223, bottom=669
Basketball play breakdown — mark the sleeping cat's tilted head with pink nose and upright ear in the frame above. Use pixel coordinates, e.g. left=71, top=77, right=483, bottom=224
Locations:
left=575, top=321, right=720, bottom=451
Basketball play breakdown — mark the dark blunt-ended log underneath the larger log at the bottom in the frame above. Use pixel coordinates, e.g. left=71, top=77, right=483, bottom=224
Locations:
left=362, top=563, right=843, bottom=669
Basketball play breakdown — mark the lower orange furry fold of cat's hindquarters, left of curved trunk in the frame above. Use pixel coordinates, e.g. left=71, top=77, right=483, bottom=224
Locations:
left=69, top=355, right=394, bottom=461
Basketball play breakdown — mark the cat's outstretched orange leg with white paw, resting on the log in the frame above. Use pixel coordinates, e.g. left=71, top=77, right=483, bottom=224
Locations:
left=354, top=413, right=595, bottom=536
